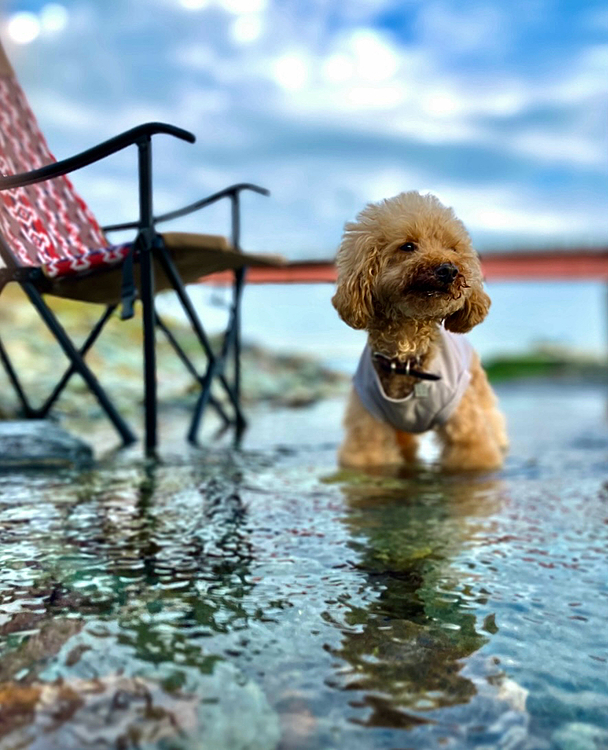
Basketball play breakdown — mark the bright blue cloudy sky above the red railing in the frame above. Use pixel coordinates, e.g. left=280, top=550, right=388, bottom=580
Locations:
left=0, top=0, right=608, bottom=258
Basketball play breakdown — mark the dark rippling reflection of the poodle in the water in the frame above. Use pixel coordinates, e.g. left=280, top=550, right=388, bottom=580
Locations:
left=326, top=472, right=505, bottom=729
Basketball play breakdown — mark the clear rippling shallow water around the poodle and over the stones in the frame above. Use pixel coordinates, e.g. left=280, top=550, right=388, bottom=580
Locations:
left=0, top=385, right=608, bottom=750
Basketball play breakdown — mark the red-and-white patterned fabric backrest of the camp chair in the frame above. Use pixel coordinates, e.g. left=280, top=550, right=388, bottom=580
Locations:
left=0, top=44, right=107, bottom=266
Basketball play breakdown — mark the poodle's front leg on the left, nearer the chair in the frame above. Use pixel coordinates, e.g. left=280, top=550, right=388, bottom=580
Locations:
left=338, top=388, right=411, bottom=469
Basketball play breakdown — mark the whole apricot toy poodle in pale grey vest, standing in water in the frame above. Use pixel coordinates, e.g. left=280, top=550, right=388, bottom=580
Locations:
left=332, top=191, right=508, bottom=471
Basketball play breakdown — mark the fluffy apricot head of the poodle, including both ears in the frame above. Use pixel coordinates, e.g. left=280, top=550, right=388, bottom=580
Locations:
left=332, top=192, right=490, bottom=333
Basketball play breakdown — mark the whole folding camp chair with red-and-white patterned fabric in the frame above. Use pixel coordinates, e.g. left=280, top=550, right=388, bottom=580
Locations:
left=0, top=41, right=282, bottom=451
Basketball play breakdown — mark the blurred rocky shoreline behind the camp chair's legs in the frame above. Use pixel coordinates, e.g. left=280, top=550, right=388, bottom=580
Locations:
left=0, top=287, right=349, bottom=419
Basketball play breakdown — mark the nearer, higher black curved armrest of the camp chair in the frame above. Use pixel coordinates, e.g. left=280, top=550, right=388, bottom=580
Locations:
left=0, top=122, right=196, bottom=190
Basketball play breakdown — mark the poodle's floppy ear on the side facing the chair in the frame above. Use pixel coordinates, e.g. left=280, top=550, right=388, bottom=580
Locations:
left=332, top=224, right=378, bottom=329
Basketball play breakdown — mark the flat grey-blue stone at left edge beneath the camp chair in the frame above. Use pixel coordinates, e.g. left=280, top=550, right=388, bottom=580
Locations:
left=0, top=419, right=93, bottom=470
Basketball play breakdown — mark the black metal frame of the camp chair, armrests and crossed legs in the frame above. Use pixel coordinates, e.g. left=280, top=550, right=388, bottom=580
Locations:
left=0, top=122, right=270, bottom=453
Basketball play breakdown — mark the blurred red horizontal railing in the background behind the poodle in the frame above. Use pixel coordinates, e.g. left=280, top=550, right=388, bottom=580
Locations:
left=201, top=253, right=608, bottom=286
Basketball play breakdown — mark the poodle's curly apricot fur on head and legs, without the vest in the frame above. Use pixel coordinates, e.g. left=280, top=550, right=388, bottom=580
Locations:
left=332, top=191, right=508, bottom=470
